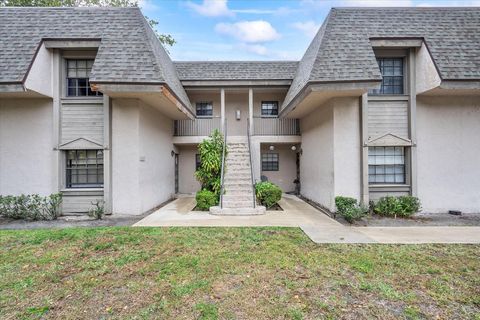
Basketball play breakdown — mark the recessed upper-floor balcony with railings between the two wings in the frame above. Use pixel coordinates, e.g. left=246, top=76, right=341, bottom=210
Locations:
left=173, top=87, right=300, bottom=137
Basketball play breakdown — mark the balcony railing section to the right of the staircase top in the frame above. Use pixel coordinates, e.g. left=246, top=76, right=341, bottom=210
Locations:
left=253, top=117, right=300, bottom=136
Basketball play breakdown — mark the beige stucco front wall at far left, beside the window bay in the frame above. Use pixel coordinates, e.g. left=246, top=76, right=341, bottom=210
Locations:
left=0, top=99, right=58, bottom=195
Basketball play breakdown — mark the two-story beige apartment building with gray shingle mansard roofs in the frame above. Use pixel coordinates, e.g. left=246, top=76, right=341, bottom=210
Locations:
left=0, top=8, right=480, bottom=214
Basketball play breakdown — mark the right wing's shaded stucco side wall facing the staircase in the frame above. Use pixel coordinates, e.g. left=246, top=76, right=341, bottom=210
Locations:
left=300, top=103, right=334, bottom=210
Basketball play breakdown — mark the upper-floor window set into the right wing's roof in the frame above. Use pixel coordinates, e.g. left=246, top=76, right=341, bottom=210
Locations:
left=371, top=58, right=405, bottom=94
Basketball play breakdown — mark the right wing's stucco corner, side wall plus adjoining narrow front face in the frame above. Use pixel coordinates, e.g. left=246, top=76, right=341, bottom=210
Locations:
left=300, top=97, right=361, bottom=211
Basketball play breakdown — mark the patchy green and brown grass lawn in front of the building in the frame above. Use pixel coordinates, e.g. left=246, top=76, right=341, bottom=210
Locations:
left=0, top=227, right=480, bottom=320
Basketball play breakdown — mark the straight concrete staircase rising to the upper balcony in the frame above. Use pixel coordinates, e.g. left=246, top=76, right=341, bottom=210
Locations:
left=210, top=137, right=265, bottom=215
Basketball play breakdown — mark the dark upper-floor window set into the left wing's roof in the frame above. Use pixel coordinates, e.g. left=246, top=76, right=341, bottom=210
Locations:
left=67, top=59, right=102, bottom=97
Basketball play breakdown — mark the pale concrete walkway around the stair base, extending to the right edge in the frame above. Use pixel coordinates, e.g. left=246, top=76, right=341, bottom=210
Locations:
left=134, top=195, right=480, bottom=244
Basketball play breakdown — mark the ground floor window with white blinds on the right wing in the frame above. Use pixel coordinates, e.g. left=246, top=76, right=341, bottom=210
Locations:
left=368, top=147, right=406, bottom=184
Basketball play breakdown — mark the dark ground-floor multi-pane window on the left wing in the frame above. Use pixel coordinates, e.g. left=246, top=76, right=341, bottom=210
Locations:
left=66, top=150, right=103, bottom=188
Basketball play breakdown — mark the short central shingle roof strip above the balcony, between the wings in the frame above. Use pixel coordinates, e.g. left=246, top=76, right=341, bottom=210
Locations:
left=174, top=61, right=298, bottom=80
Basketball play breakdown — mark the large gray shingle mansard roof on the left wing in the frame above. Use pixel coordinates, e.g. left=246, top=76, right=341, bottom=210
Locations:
left=0, top=7, right=190, bottom=107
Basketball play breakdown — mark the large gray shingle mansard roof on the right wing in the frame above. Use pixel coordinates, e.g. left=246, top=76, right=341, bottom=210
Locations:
left=283, top=7, right=480, bottom=111
